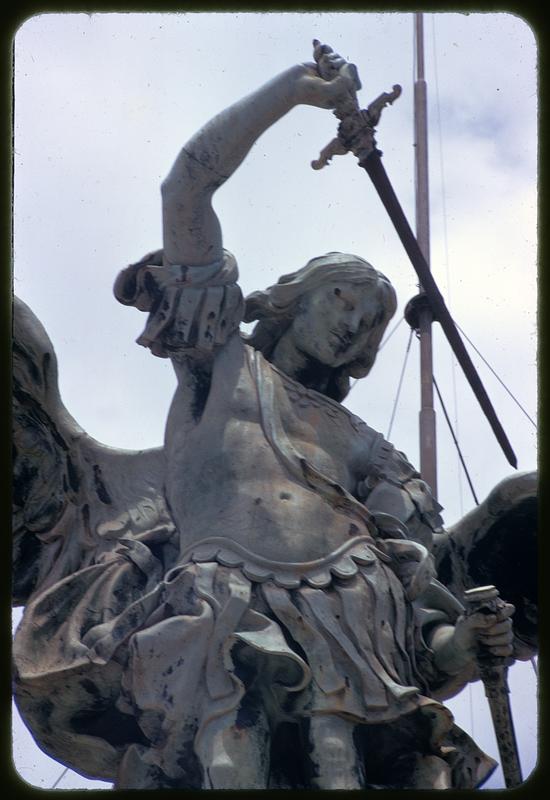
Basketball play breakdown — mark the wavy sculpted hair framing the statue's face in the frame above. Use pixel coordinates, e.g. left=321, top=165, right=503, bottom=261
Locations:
left=243, top=252, right=397, bottom=401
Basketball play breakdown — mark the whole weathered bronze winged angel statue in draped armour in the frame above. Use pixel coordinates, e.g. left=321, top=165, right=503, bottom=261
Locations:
left=13, top=42, right=536, bottom=789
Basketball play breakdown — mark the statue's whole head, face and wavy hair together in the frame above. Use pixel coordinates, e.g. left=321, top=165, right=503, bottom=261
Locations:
left=244, top=253, right=397, bottom=400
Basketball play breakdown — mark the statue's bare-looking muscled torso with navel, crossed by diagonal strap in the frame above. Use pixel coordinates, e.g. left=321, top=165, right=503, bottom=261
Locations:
left=166, top=336, right=376, bottom=561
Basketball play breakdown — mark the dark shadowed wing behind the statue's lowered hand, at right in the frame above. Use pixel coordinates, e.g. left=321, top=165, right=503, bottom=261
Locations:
left=435, top=472, right=538, bottom=660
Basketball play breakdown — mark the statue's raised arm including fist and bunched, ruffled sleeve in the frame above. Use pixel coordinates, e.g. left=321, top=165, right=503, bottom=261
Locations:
left=114, top=43, right=356, bottom=361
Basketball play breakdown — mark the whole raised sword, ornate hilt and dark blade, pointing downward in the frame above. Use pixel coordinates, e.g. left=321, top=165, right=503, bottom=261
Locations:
left=311, top=39, right=517, bottom=467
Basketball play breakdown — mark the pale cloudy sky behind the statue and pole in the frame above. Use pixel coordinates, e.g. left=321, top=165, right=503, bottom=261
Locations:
left=14, top=13, right=537, bottom=788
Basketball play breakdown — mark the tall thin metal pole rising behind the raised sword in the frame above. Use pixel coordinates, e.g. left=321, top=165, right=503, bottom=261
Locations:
left=414, top=13, right=437, bottom=497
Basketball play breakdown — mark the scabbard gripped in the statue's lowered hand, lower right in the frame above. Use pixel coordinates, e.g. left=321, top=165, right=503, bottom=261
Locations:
left=464, top=586, right=523, bottom=789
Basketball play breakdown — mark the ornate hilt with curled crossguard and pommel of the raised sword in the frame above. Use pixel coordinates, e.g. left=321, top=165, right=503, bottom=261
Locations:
left=311, top=39, right=401, bottom=169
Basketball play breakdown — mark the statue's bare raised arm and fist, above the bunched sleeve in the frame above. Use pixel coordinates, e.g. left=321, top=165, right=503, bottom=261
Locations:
left=162, top=45, right=360, bottom=266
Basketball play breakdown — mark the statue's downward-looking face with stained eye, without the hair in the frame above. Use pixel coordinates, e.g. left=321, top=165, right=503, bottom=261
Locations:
left=290, top=281, right=380, bottom=367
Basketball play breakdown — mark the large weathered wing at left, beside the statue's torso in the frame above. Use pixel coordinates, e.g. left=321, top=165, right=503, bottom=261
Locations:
left=12, top=298, right=177, bottom=605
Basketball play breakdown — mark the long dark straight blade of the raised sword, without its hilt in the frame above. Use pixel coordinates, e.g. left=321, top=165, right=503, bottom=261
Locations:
left=359, top=150, right=517, bottom=467
